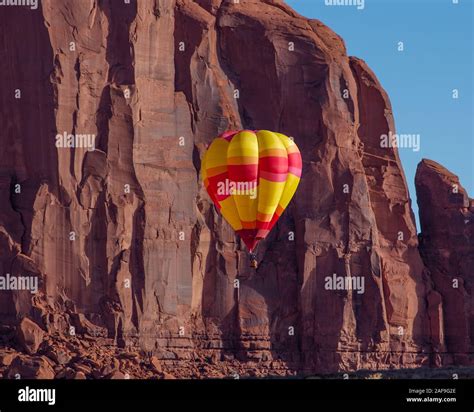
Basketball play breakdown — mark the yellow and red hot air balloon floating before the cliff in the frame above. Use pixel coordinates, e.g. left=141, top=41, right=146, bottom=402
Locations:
left=201, top=130, right=302, bottom=268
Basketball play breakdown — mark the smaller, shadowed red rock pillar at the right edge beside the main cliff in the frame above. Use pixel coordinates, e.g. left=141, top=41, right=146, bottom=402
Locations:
left=415, top=160, right=474, bottom=364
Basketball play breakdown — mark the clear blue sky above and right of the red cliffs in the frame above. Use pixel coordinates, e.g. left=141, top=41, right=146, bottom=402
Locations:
left=286, top=0, right=474, bottom=230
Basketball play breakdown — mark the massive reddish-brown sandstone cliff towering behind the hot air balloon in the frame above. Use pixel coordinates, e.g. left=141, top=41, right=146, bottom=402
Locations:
left=0, top=0, right=472, bottom=378
